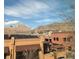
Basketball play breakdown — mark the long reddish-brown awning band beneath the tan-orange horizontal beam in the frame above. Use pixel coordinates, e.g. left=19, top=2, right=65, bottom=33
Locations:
left=16, top=44, right=40, bottom=52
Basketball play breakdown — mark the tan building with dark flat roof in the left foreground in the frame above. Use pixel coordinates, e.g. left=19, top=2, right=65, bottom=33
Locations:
left=4, top=35, right=41, bottom=59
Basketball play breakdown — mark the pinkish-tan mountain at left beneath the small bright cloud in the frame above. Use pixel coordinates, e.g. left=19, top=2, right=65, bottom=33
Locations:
left=4, top=24, right=31, bottom=34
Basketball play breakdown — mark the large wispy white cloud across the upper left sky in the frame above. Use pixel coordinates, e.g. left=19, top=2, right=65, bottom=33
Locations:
left=5, top=0, right=50, bottom=18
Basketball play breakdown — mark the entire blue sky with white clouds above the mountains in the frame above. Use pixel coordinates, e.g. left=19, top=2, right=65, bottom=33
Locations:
left=4, top=0, right=75, bottom=28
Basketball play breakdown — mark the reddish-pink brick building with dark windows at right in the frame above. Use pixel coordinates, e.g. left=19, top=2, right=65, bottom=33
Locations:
left=46, top=32, right=75, bottom=50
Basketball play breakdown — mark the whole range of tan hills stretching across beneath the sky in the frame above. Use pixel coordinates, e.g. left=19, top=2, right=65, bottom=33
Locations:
left=4, top=21, right=75, bottom=34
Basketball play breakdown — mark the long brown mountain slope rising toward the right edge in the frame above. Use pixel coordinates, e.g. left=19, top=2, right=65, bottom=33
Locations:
left=35, top=20, right=75, bottom=32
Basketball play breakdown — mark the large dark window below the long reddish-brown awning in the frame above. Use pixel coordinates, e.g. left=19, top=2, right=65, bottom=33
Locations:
left=16, top=50, right=39, bottom=59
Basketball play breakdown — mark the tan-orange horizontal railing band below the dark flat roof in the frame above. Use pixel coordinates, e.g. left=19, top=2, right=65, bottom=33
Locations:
left=4, top=38, right=40, bottom=47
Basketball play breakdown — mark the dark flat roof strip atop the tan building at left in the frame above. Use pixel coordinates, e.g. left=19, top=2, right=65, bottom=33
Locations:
left=4, top=34, right=39, bottom=39
